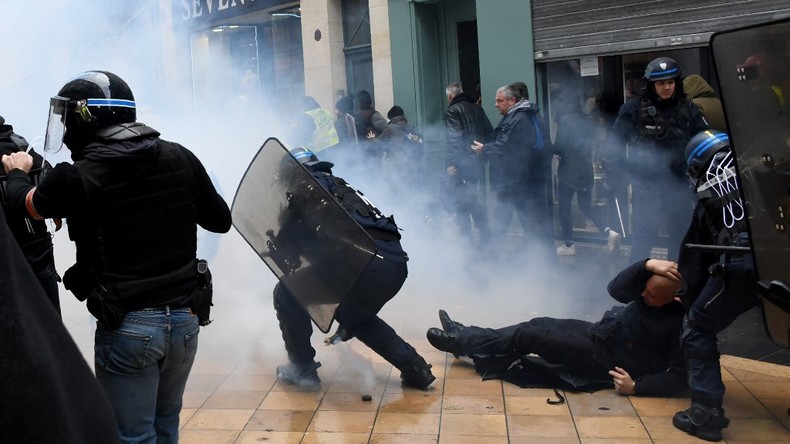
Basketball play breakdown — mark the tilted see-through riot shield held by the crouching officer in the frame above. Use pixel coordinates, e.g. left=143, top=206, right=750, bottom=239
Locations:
left=231, top=138, right=376, bottom=333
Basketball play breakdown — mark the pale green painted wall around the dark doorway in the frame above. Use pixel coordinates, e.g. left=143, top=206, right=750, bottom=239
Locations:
left=388, top=0, right=537, bottom=194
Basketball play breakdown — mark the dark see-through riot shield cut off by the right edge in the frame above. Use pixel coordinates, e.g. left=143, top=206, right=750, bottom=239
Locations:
left=711, top=20, right=790, bottom=347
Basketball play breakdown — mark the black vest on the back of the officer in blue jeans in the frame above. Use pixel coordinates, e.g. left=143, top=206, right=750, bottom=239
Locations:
left=68, top=140, right=197, bottom=299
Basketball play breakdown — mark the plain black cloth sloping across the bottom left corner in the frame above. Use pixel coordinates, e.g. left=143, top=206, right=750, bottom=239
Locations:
left=0, top=203, right=120, bottom=444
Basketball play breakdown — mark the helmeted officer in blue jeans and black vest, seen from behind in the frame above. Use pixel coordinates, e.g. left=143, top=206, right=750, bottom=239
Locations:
left=2, top=71, right=231, bottom=443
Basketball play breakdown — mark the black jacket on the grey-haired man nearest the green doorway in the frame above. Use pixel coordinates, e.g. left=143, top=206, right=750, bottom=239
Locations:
left=444, top=93, right=494, bottom=170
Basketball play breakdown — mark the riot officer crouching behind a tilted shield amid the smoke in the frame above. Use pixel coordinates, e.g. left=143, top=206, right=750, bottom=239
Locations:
left=270, top=148, right=436, bottom=390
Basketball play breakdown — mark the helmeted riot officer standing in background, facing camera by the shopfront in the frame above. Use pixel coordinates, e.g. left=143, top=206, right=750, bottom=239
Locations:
left=606, top=57, right=708, bottom=261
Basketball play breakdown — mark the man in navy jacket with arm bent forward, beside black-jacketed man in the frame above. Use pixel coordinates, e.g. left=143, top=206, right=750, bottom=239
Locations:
left=472, top=85, right=556, bottom=260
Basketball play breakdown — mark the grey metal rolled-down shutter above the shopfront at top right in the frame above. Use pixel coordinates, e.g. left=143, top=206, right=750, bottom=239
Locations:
left=532, top=0, right=790, bottom=62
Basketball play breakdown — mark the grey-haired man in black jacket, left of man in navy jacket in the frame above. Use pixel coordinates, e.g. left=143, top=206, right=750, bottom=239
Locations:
left=444, top=83, right=494, bottom=246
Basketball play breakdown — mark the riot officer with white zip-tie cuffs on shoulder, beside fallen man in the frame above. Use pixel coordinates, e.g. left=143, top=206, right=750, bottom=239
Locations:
left=672, top=130, right=757, bottom=441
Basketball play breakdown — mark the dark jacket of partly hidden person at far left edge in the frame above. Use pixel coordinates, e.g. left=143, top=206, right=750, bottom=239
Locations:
left=0, top=116, right=54, bottom=268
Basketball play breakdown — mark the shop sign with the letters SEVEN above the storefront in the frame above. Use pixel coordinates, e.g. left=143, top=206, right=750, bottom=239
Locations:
left=173, top=0, right=288, bottom=25
